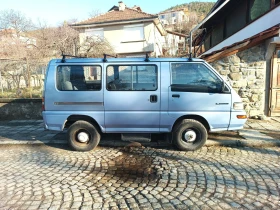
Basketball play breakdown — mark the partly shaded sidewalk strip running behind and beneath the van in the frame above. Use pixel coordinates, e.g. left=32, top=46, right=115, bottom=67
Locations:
left=0, top=118, right=280, bottom=147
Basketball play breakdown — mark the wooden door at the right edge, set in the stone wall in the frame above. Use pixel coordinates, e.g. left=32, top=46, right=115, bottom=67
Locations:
left=269, top=46, right=280, bottom=116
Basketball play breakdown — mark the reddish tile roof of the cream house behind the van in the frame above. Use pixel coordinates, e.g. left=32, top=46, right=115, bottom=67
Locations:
left=73, top=6, right=158, bottom=26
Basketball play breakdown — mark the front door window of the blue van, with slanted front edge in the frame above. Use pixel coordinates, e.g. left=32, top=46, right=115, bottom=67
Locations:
left=171, top=63, right=223, bottom=93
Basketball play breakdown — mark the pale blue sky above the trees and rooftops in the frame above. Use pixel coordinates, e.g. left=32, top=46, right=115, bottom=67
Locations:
left=0, top=0, right=216, bottom=26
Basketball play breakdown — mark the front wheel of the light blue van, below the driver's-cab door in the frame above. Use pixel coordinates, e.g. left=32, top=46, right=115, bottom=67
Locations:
left=173, top=119, right=208, bottom=151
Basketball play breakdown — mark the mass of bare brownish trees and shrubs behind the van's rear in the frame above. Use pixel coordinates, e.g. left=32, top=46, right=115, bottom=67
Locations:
left=0, top=10, right=114, bottom=97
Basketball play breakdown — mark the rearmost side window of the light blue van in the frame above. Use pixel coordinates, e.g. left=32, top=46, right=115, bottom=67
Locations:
left=56, top=65, right=101, bottom=91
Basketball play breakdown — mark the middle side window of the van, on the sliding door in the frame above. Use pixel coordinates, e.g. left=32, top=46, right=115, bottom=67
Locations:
left=106, top=65, right=158, bottom=91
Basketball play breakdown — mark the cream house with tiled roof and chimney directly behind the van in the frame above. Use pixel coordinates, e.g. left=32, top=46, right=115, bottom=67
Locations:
left=71, top=1, right=184, bottom=57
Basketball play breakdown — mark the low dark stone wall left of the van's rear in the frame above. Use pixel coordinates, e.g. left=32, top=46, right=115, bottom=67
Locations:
left=0, top=98, right=42, bottom=120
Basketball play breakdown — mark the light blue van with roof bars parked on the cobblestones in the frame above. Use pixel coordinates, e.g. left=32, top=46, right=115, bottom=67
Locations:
left=43, top=55, right=247, bottom=151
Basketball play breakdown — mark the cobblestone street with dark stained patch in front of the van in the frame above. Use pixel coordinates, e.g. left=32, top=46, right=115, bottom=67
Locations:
left=0, top=145, right=280, bottom=210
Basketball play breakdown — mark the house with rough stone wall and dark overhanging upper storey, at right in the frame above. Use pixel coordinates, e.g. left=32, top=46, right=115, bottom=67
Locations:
left=193, top=0, right=280, bottom=117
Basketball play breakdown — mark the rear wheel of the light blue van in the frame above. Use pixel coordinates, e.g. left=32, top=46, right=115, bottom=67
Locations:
left=67, top=121, right=100, bottom=152
